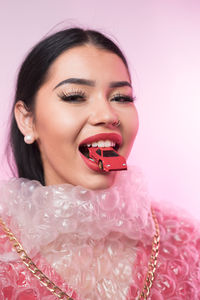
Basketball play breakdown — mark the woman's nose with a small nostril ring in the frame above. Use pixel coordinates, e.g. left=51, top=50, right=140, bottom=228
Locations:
left=89, top=98, right=119, bottom=127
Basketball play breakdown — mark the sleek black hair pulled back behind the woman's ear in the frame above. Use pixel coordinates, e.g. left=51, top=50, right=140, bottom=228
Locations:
left=9, top=27, right=129, bottom=185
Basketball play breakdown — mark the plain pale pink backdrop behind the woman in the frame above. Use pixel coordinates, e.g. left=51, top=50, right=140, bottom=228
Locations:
left=0, top=0, right=200, bottom=218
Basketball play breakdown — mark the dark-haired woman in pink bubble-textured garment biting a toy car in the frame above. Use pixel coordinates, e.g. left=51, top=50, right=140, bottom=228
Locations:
left=0, top=28, right=200, bottom=300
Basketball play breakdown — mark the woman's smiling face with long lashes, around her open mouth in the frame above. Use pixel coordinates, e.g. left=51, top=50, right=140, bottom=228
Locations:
left=34, top=45, right=138, bottom=189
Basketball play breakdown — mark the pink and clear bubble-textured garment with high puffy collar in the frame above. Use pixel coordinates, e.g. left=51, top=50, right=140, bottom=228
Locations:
left=0, top=167, right=200, bottom=300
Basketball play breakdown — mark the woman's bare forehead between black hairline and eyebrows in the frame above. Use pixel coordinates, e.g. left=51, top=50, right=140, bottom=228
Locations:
left=45, top=44, right=130, bottom=81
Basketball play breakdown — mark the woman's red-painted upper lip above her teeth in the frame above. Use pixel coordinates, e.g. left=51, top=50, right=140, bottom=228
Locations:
left=79, top=132, right=122, bottom=146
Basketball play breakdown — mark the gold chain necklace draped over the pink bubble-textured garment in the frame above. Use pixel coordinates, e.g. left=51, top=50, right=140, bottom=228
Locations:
left=0, top=208, right=160, bottom=300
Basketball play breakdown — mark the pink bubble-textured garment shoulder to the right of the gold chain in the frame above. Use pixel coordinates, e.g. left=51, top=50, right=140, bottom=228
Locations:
left=154, top=205, right=200, bottom=300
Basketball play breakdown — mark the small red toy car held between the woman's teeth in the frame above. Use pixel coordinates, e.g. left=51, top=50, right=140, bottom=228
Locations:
left=88, top=147, right=127, bottom=172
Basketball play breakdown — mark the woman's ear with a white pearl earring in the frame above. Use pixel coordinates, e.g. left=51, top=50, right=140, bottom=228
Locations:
left=14, top=100, right=36, bottom=144
